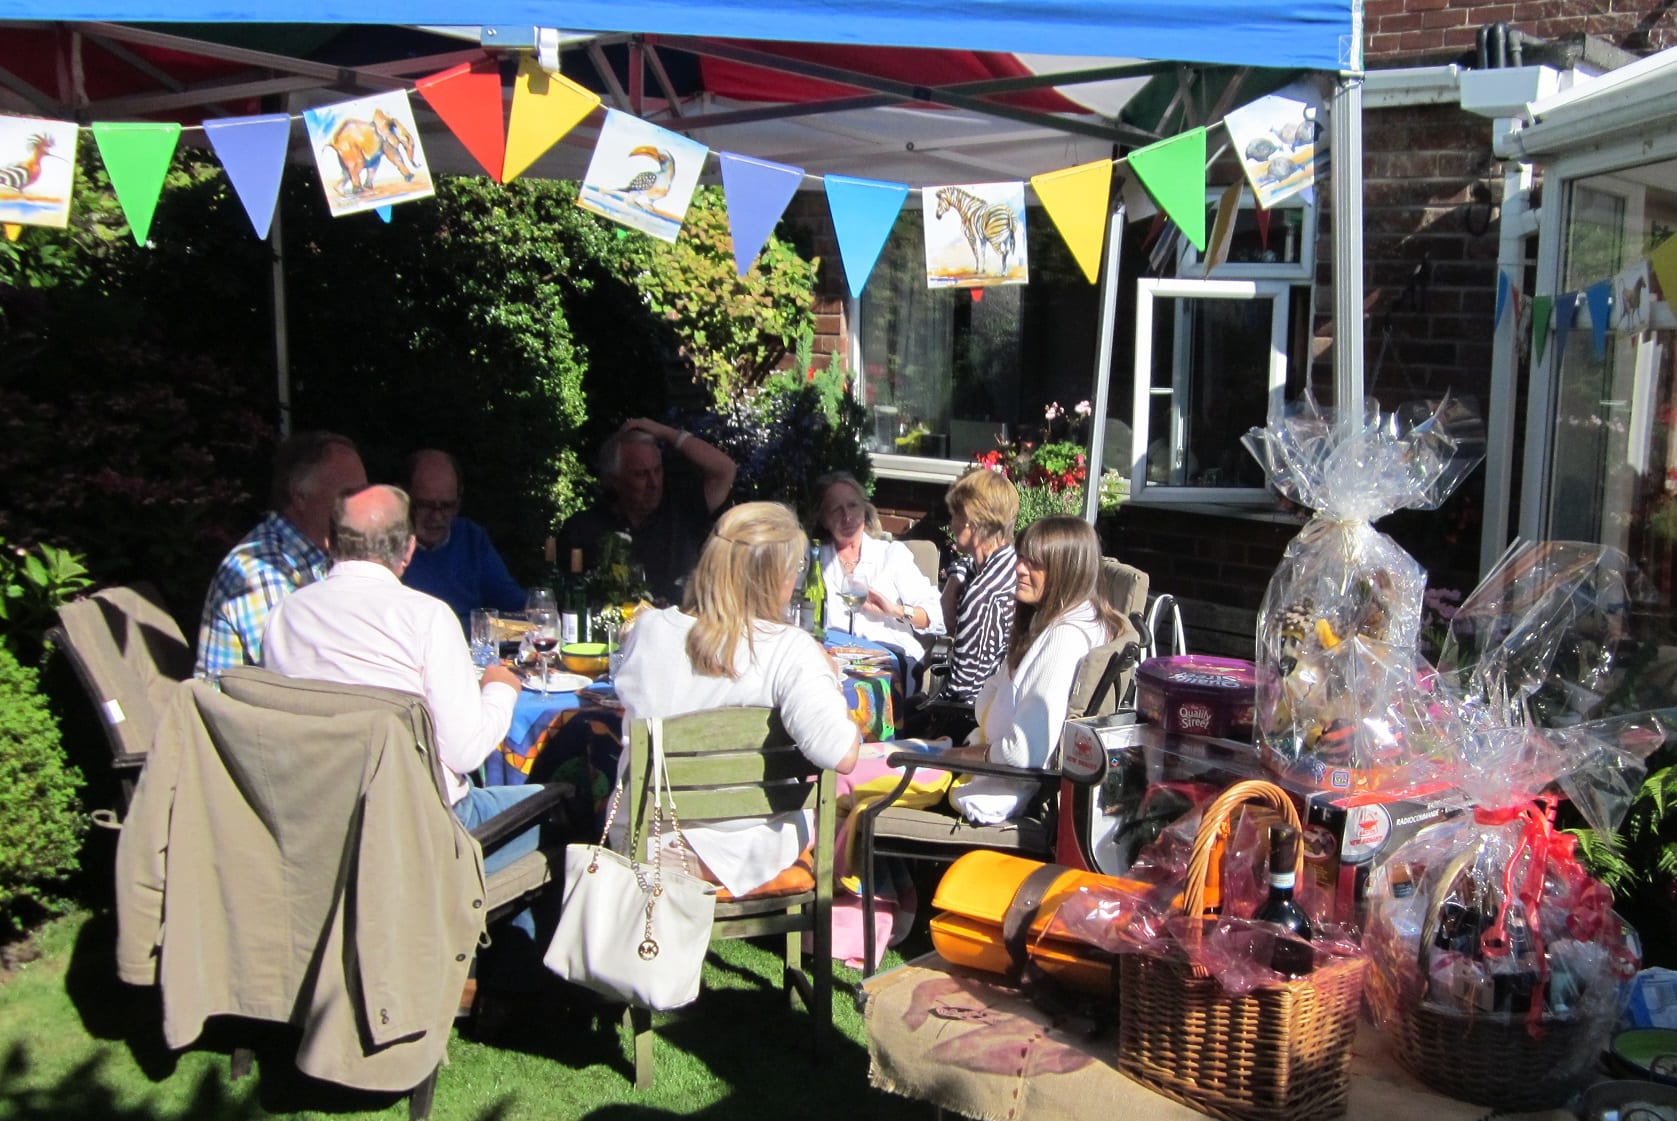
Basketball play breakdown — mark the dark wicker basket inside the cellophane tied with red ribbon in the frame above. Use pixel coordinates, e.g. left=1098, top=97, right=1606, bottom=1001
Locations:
left=1377, top=835, right=1613, bottom=1111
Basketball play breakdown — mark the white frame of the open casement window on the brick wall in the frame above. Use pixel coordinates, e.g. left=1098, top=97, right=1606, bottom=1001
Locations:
left=1129, top=279, right=1296, bottom=505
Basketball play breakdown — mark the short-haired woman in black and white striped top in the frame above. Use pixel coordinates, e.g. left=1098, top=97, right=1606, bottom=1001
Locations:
left=902, top=467, right=1020, bottom=743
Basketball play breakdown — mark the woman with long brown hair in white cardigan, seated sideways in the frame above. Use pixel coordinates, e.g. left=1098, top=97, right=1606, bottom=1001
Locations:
left=946, top=517, right=1129, bottom=824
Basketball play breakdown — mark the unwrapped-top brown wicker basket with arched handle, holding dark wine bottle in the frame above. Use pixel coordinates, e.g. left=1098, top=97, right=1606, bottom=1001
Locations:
left=1119, top=780, right=1363, bottom=1121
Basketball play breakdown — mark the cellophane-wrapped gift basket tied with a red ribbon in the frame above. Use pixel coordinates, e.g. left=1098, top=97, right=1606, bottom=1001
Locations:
left=1363, top=542, right=1665, bottom=1109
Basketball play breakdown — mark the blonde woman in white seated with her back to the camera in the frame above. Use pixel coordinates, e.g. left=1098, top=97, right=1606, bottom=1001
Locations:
left=614, top=502, right=860, bottom=896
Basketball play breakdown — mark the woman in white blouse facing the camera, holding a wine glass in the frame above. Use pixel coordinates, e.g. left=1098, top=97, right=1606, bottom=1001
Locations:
left=815, top=472, right=944, bottom=681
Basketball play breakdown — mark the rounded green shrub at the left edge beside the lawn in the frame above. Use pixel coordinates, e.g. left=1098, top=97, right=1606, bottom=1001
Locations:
left=0, top=646, right=86, bottom=928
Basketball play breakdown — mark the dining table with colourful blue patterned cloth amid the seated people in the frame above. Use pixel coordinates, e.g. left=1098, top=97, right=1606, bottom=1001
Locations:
left=483, top=631, right=901, bottom=797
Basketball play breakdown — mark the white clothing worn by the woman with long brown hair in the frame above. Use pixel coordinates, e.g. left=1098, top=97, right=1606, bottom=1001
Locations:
left=949, top=602, right=1107, bottom=826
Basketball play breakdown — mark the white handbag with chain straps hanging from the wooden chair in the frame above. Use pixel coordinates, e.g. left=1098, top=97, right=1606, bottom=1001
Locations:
left=542, top=720, right=716, bottom=1010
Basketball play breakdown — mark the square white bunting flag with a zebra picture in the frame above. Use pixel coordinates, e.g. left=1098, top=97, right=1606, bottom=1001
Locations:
left=921, top=181, right=1030, bottom=289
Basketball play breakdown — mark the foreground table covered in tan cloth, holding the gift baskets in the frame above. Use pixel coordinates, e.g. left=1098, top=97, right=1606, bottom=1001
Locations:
left=862, top=953, right=1573, bottom=1121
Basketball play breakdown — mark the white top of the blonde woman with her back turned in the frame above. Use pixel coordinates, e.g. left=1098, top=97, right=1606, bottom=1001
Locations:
left=612, top=607, right=857, bottom=894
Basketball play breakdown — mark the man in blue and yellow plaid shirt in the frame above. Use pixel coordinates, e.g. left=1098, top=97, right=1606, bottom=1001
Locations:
left=193, top=431, right=367, bottom=680
